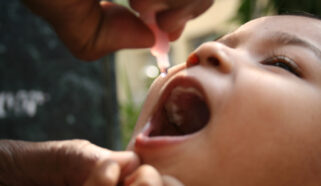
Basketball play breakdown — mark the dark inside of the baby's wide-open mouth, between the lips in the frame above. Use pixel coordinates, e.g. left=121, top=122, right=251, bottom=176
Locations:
left=147, top=77, right=210, bottom=137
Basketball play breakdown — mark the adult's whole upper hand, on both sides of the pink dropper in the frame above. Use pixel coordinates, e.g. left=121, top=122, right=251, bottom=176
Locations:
left=23, top=0, right=213, bottom=60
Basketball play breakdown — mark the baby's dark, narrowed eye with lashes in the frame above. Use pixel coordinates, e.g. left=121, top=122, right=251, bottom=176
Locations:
left=263, top=56, right=301, bottom=77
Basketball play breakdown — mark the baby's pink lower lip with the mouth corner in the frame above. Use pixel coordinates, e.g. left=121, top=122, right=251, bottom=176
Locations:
left=135, top=123, right=191, bottom=149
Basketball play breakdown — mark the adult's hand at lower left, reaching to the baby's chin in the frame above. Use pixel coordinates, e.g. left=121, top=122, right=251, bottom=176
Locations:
left=0, top=140, right=139, bottom=186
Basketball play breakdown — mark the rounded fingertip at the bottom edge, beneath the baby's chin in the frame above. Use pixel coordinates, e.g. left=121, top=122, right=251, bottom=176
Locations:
left=125, top=165, right=163, bottom=186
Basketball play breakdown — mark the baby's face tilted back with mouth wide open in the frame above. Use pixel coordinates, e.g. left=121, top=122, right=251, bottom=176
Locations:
left=129, top=16, right=321, bottom=186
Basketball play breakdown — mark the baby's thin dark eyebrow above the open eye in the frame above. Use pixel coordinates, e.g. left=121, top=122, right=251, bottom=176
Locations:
left=272, top=32, right=321, bottom=58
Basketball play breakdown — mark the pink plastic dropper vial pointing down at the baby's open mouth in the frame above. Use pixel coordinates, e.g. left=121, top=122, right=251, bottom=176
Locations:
left=141, top=13, right=170, bottom=77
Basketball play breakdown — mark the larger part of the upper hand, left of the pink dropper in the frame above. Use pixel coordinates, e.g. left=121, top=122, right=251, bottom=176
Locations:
left=23, top=0, right=154, bottom=60
